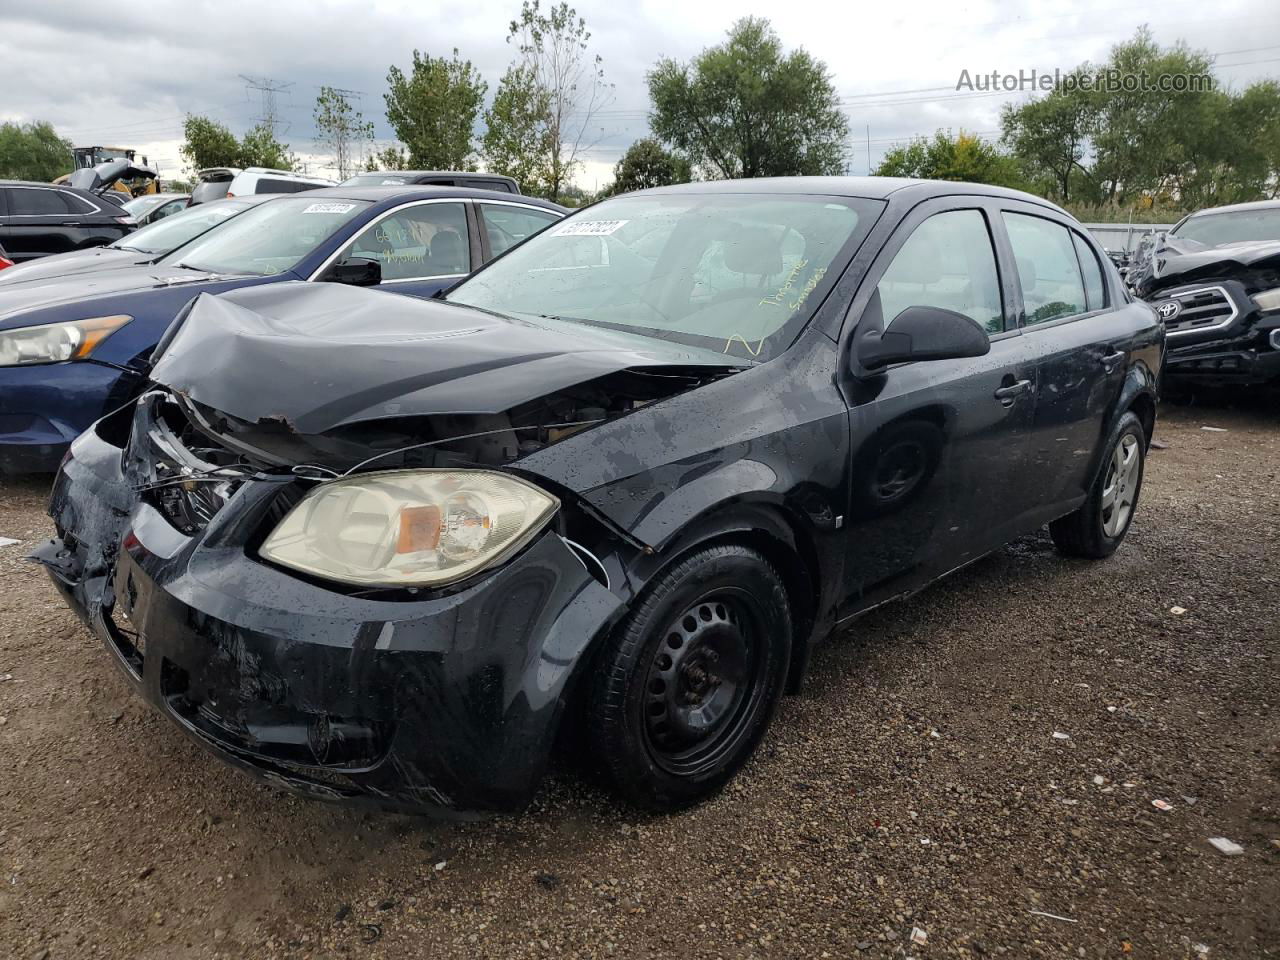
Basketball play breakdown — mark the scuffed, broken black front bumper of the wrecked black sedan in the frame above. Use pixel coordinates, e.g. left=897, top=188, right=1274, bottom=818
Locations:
left=41, top=417, right=634, bottom=815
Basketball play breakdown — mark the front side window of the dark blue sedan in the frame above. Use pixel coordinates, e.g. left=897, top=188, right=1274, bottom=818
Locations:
left=338, top=204, right=471, bottom=282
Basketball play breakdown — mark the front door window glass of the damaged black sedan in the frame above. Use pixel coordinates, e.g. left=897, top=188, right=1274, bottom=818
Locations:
left=877, top=210, right=1005, bottom=333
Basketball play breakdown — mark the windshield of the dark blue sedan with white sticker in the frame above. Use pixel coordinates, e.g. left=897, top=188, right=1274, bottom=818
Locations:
left=160, top=197, right=369, bottom=276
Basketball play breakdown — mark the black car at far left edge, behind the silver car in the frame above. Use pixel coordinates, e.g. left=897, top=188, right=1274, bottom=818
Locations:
left=0, top=180, right=137, bottom=264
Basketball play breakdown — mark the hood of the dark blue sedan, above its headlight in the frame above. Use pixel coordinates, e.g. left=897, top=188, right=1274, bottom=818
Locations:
left=0, top=264, right=240, bottom=330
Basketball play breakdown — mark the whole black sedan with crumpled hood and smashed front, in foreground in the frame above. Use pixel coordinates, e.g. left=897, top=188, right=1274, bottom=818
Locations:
left=35, top=178, right=1164, bottom=815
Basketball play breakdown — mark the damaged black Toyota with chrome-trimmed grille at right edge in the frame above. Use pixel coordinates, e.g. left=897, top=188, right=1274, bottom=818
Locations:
left=1128, top=200, right=1280, bottom=387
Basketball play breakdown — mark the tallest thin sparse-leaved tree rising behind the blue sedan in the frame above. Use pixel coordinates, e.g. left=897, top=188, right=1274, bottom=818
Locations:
left=498, top=0, right=612, bottom=200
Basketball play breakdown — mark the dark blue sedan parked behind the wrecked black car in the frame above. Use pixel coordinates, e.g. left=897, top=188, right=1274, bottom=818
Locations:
left=0, top=186, right=566, bottom=472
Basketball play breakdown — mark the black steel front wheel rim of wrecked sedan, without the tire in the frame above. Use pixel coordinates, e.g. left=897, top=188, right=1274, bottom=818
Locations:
left=640, top=589, right=765, bottom=776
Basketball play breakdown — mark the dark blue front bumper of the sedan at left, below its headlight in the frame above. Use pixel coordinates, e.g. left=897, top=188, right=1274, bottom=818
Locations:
left=0, top=360, right=140, bottom=474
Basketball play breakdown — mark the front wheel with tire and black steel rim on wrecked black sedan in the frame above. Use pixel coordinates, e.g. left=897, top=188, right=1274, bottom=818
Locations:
left=588, top=544, right=792, bottom=813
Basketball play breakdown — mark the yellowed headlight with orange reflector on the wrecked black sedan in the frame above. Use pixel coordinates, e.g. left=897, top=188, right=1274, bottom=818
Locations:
left=261, top=470, right=559, bottom=586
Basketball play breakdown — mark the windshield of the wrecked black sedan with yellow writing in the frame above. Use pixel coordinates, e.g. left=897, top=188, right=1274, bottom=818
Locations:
left=448, top=193, right=883, bottom=360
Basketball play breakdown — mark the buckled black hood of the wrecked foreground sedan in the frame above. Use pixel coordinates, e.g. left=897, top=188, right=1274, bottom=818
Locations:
left=151, top=283, right=751, bottom=434
